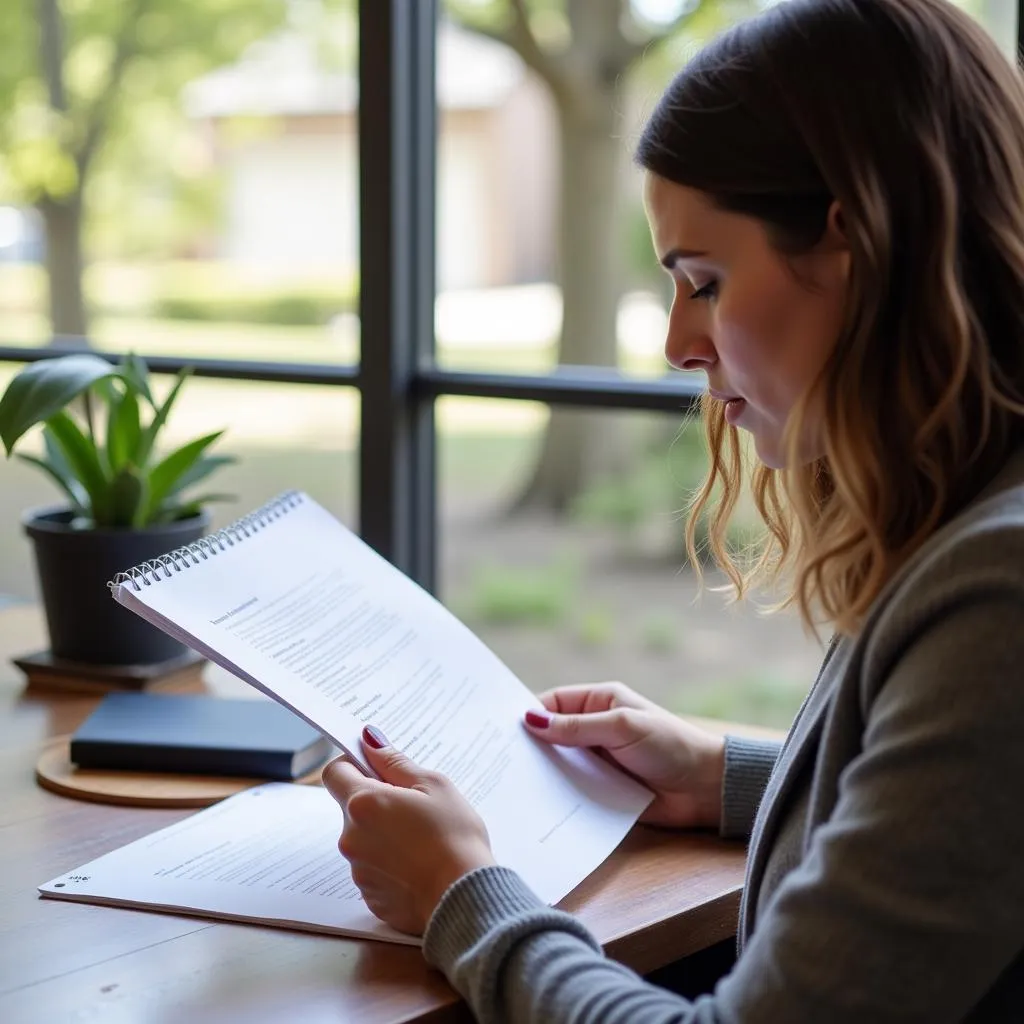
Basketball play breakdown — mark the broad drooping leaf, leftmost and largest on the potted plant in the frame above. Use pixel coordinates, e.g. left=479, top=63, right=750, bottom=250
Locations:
left=0, top=355, right=120, bottom=456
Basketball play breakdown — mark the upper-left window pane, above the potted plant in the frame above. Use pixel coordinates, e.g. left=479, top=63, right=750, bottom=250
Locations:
left=0, top=0, right=358, bottom=362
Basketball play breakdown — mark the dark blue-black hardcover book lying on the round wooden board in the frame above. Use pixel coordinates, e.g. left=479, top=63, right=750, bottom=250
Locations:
left=71, top=693, right=334, bottom=779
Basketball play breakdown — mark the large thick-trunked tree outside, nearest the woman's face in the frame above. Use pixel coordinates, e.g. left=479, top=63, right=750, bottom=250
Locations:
left=449, top=0, right=745, bottom=511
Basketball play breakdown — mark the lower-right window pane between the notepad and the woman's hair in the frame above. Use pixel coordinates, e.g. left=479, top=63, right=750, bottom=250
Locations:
left=438, top=397, right=821, bottom=727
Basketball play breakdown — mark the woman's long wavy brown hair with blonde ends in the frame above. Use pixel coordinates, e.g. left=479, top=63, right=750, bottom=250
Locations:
left=636, top=0, right=1024, bottom=634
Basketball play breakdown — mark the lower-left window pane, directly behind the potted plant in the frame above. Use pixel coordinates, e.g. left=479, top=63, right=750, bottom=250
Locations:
left=0, top=366, right=358, bottom=605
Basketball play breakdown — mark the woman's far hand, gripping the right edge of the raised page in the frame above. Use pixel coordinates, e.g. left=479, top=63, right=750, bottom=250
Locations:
left=525, top=683, right=725, bottom=828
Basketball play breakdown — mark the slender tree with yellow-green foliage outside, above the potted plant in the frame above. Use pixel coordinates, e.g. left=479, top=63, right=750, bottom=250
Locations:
left=0, top=0, right=285, bottom=341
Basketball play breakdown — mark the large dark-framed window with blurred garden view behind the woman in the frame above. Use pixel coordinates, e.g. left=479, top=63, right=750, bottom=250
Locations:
left=0, top=0, right=1017, bottom=725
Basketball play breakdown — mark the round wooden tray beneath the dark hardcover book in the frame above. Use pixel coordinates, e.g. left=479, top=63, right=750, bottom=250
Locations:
left=36, top=736, right=323, bottom=807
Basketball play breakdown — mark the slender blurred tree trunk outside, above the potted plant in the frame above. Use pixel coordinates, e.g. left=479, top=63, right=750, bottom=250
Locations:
left=38, top=189, right=88, bottom=345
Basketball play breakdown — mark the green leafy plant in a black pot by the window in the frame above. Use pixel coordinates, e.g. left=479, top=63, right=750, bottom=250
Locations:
left=0, top=354, right=233, bottom=666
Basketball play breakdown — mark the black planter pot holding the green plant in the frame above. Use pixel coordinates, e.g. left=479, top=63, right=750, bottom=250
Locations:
left=23, top=508, right=210, bottom=665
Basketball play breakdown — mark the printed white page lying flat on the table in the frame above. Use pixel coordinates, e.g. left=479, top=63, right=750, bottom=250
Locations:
left=39, top=782, right=419, bottom=945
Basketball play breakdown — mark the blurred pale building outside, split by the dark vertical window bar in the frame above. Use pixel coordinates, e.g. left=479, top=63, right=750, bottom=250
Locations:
left=185, top=24, right=557, bottom=289
